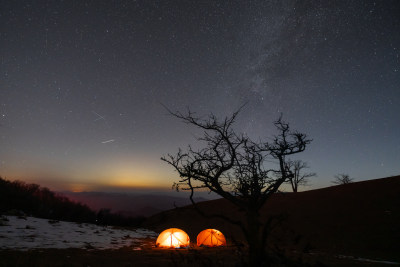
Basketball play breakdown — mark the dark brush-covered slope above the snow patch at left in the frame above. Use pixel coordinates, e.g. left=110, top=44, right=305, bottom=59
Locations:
left=0, top=177, right=145, bottom=227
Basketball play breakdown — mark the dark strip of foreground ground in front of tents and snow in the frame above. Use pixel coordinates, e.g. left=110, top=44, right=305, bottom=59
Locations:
left=0, top=239, right=396, bottom=267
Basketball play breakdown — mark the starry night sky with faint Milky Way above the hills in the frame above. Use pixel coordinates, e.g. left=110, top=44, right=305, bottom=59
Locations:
left=0, top=0, right=400, bottom=191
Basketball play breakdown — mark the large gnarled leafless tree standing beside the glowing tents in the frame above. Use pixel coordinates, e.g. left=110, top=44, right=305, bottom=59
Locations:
left=161, top=109, right=311, bottom=266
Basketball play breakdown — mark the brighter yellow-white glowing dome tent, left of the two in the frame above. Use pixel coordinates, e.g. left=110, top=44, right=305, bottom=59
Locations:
left=156, top=228, right=190, bottom=248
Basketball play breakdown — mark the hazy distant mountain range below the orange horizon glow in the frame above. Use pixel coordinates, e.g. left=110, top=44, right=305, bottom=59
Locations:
left=60, top=192, right=208, bottom=217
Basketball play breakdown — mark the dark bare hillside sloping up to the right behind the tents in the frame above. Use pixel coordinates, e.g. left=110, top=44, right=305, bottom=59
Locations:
left=144, top=176, right=400, bottom=262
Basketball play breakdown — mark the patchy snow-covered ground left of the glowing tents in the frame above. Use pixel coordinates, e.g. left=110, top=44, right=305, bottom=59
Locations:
left=0, top=216, right=157, bottom=250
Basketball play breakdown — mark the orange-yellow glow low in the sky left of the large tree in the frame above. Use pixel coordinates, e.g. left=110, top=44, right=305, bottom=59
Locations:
left=3, top=159, right=176, bottom=192
